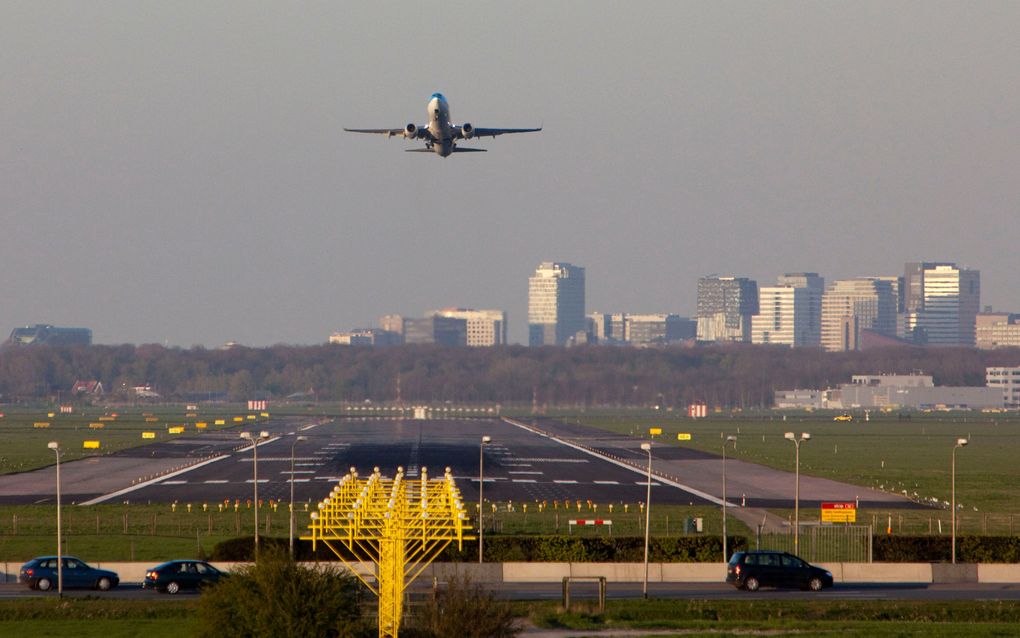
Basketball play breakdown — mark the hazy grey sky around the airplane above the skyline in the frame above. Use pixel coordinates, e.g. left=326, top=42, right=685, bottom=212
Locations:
left=0, top=0, right=1020, bottom=347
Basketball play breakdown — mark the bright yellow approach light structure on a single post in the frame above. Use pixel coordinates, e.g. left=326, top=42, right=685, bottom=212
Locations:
left=302, top=468, right=475, bottom=638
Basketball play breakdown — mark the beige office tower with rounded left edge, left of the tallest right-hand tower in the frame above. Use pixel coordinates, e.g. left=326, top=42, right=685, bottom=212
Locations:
left=821, top=277, right=899, bottom=352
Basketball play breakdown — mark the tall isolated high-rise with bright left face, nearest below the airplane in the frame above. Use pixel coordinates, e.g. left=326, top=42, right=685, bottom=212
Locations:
left=527, top=261, right=587, bottom=346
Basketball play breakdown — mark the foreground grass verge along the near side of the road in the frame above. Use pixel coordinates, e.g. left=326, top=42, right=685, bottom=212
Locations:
left=0, top=597, right=1020, bottom=638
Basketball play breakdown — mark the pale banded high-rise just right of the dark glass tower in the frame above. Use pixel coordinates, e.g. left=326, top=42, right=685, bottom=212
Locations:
left=751, top=273, right=825, bottom=347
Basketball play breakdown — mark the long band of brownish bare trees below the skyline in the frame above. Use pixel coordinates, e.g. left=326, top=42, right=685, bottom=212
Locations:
left=0, top=344, right=1020, bottom=407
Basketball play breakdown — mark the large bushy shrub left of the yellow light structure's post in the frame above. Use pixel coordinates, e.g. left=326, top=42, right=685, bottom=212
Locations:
left=197, top=545, right=364, bottom=638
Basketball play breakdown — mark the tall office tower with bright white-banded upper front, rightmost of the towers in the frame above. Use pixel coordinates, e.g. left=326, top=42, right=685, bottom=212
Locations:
left=904, top=262, right=981, bottom=346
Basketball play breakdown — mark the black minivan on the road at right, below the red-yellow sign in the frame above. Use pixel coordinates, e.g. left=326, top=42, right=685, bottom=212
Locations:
left=726, top=550, right=832, bottom=591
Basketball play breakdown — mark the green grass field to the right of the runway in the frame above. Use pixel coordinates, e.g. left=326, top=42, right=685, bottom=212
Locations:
left=565, top=413, right=1020, bottom=514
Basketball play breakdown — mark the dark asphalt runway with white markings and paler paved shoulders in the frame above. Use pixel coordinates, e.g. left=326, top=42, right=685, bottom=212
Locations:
left=0, top=419, right=915, bottom=510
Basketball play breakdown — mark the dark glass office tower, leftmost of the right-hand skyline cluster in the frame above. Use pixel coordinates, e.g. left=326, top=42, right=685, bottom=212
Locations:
left=698, top=277, right=758, bottom=342
